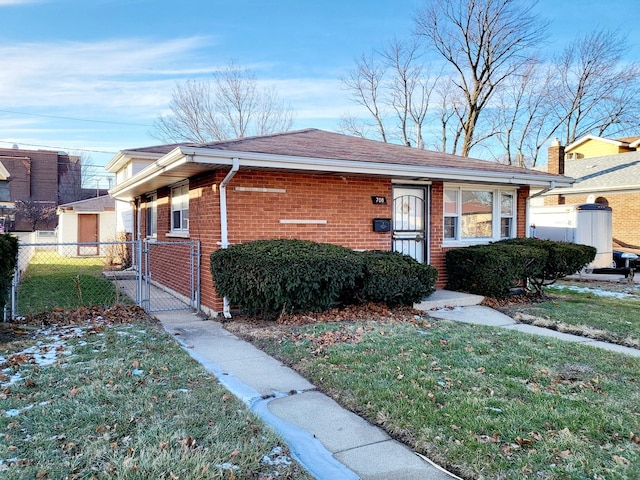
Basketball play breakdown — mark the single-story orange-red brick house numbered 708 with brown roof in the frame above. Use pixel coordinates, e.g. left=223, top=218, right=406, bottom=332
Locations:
left=106, top=129, right=573, bottom=313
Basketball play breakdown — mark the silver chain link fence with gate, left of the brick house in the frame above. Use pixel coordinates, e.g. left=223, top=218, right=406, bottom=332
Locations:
left=4, top=241, right=200, bottom=319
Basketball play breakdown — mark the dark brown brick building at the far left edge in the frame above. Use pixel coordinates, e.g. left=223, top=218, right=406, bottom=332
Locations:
left=0, top=148, right=82, bottom=231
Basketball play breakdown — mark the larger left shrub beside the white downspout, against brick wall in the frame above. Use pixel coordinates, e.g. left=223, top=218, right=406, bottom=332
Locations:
left=211, top=240, right=362, bottom=313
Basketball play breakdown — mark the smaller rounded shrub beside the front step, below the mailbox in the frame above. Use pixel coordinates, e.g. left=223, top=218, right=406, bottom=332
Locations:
left=355, top=251, right=438, bottom=306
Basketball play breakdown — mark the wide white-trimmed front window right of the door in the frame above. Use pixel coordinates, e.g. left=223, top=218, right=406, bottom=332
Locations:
left=443, top=185, right=516, bottom=243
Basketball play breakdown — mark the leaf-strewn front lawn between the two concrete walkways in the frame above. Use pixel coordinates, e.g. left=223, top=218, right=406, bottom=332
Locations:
left=240, top=319, right=640, bottom=480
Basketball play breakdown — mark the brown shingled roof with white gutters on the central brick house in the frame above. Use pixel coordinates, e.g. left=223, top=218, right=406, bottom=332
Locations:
left=107, top=129, right=572, bottom=199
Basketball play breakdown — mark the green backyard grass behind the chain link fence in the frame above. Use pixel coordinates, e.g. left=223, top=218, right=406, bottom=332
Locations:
left=18, top=252, right=126, bottom=315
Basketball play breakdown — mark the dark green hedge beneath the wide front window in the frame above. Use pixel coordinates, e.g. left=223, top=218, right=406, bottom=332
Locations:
left=446, top=238, right=596, bottom=298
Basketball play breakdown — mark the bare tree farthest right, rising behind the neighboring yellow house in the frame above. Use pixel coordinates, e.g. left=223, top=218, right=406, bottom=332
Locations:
left=495, top=31, right=640, bottom=167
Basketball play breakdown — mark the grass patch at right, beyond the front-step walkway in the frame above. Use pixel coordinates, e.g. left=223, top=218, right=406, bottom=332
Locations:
left=500, top=288, right=640, bottom=348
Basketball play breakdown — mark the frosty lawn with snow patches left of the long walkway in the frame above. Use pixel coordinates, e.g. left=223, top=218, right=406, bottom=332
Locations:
left=0, top=322, right=311, bottom=480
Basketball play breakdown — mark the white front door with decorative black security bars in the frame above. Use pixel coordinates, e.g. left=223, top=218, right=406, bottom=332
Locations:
left=393, top=187, right=429, bottom=263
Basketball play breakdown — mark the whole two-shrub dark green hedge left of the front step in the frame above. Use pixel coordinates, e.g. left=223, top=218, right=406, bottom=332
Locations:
left=211, top=240, right=437, bottom=316
